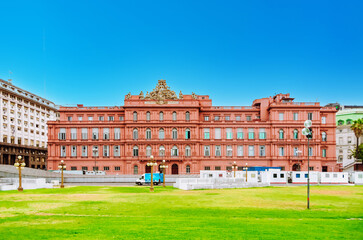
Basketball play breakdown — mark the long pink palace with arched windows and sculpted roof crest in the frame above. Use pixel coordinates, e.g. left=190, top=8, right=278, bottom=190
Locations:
left=47, top=80, right=339, bottom=174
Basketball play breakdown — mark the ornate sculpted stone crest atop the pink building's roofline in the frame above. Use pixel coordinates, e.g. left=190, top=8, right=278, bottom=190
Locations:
left=140, top=80, right=183, bottom=104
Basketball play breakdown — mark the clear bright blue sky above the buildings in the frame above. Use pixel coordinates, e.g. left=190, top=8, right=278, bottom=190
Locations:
left=0, top=0, right=363, bottom=106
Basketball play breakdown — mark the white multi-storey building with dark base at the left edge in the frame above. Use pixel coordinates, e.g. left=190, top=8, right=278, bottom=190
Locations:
left=0, top=79, right=58, bottom=169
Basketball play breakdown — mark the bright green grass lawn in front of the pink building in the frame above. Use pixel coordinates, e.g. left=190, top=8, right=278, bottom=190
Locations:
left=0, top=186, right=363, bottom=240
